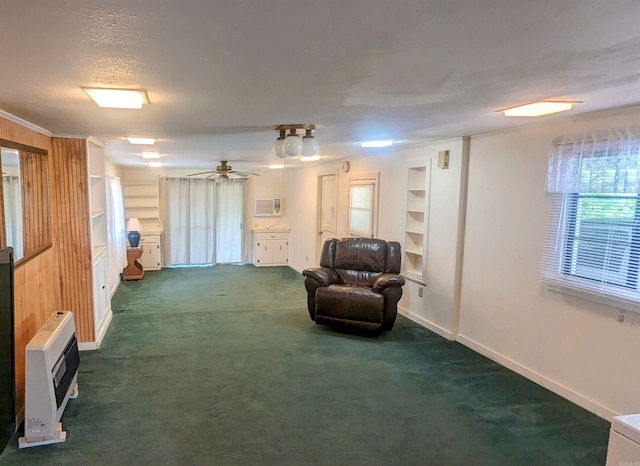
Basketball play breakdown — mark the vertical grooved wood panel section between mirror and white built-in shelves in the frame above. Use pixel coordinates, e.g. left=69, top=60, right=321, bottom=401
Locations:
left=49, top=137, right=95, bottom=343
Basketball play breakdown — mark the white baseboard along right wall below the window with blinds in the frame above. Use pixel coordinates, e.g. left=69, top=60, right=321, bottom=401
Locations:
left=457, top=334, right=619, bottom=421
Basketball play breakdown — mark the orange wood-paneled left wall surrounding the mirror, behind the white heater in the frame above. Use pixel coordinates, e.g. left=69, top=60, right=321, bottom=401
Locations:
left=0, top=117, right=60, bottom=426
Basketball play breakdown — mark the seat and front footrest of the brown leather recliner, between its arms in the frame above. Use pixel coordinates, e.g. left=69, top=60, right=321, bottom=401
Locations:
left=316, top=285, right=384, bottom=323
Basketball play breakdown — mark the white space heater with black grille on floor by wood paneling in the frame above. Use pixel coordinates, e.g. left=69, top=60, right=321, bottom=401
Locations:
left=18, top=311, right=80, bottom=448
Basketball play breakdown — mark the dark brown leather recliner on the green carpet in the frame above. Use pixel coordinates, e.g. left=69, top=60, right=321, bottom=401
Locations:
left=302, top=238, right=404, bottom=331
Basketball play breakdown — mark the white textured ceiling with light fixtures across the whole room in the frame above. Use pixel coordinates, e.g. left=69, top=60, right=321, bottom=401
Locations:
left=0, top=0, right=640, bottom=169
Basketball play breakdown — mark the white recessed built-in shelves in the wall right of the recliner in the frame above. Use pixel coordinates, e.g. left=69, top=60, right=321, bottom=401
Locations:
left=402, top=165, right=431, bottom=285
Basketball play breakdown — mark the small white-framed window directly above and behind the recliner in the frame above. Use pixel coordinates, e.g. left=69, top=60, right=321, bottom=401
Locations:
left=348, top=174, right=378, bottom=238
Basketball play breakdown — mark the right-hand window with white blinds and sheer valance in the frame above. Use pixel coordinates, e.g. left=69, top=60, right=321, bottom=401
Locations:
left=541, top=134, right=640, bottom=309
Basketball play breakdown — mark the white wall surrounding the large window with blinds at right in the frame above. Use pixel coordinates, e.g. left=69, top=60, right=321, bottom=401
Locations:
left=458, top=108, right=640, bottom=418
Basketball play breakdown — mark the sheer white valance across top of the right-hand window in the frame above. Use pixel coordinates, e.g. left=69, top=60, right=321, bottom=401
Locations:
left=547, top=130, right=640, bottom=194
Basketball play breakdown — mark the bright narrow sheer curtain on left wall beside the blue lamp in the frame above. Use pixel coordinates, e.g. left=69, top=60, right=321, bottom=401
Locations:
left=107, top=176, right=127, bottom=291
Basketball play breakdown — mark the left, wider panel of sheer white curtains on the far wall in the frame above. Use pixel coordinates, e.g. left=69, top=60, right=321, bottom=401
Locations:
left=160, top=178, right=216, bottom=265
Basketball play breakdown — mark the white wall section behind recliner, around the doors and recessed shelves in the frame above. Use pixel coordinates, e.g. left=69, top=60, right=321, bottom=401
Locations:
left=287, top=138, right=464, bottom=339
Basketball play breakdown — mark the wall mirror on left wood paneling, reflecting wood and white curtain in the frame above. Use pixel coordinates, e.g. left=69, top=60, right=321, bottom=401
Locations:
left=0, top=139, right=51, bottom=263
